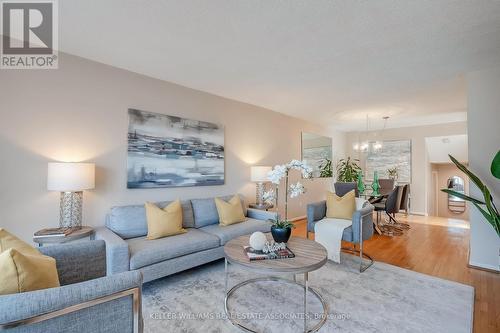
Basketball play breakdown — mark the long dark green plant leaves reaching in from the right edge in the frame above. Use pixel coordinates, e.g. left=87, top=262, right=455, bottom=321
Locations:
left=441, top=151, right=500, bottom=237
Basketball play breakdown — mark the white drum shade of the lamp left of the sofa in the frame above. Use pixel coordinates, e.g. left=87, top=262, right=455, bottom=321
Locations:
left=47, top=163, right=95, bottom=192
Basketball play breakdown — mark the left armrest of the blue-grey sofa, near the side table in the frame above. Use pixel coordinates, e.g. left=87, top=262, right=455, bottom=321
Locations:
left=95, top=227, right=130, bottom=275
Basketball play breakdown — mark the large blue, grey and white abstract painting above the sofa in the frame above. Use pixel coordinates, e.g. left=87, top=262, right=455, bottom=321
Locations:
left=127, top=109, right=224, bottom=188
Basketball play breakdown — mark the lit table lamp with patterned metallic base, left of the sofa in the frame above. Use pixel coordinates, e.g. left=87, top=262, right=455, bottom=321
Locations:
left=47, top=163, right=95, bottom=229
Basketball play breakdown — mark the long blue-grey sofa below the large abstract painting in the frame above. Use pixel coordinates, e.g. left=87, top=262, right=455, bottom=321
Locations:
left=96, top=196, right=275, bottom=282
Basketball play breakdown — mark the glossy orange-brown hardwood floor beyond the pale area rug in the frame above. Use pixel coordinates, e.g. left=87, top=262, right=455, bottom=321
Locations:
left=293, top=214, right=500, bottom=333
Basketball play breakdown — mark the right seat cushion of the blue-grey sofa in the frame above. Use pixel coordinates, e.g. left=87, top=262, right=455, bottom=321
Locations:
left=200, top=218, right=271, bottom=245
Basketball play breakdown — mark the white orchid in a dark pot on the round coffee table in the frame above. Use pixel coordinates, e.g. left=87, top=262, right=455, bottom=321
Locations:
left=264, top=160, right=312, bottom=243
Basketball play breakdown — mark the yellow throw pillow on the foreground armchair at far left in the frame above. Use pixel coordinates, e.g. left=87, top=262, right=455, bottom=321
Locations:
left=0, top=248, right=59, bottom=295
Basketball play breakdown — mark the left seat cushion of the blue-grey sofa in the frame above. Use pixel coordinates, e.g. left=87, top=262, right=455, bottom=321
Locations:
left=126, top=228, right=220, bottom=269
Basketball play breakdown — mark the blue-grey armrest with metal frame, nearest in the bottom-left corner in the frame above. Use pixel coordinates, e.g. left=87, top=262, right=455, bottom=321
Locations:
left=0, top=272, right=142, bottom=332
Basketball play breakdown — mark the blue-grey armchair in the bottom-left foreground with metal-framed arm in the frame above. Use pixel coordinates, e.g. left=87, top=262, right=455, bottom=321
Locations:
left=0, top=240, right=143, bottom=333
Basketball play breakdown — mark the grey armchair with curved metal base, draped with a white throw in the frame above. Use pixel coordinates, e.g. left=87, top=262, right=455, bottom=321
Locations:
left=307, top=201, right=373, bottom=272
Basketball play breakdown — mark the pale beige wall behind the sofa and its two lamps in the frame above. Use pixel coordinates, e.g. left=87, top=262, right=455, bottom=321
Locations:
left=0, top=53, right=345, bottom=240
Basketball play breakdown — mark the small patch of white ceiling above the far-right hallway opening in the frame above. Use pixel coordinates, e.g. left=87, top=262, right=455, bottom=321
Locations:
left=425, top=134, right=469, bottom=163
